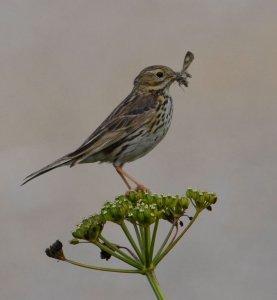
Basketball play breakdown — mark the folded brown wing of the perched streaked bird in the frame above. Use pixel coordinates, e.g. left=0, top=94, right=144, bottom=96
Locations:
left=67, top=93, right=156, bottom=165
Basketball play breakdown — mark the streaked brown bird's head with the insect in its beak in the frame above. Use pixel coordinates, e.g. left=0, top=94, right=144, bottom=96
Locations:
left=134, top=52, right=194, bottom=91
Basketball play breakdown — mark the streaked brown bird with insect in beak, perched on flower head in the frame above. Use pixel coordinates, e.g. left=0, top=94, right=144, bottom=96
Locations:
left=22, top=51, right=194, bottom=192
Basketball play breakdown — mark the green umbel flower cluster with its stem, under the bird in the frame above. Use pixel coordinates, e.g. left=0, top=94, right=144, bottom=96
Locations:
left=46, top=189, right=217, bottom=299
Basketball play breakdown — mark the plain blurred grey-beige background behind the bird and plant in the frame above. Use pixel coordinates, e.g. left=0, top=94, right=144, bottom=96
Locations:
left=0, top=0, right=277, bottom=300
